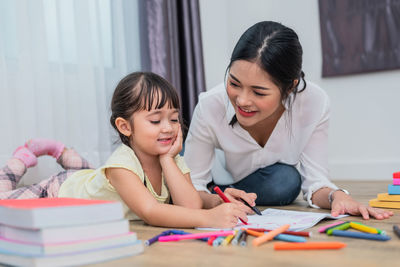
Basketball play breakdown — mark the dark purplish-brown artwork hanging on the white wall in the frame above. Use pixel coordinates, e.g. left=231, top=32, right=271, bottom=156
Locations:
left=319, top=0, right=400, bottom=77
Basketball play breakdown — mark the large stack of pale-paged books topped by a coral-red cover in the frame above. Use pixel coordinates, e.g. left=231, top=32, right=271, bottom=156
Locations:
left=0, top=198, right=143, bottom=266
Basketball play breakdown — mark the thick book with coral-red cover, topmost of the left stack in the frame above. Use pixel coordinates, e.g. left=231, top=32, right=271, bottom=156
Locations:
left=0, top=198, right=124, bottom=229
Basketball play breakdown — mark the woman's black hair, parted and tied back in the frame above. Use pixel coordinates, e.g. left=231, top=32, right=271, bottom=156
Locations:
left=226, top=21, right=306, bottom=125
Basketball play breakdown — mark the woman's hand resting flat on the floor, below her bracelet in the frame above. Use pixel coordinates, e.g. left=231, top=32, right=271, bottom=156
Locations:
left=331, top=191, right=393, bottom=220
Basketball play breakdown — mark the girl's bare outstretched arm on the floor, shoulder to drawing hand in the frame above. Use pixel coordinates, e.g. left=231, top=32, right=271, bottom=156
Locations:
left=106, top=168, right=247, bottom=228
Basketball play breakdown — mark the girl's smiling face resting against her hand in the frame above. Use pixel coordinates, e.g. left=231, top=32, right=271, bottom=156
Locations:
left=130, top=103, right=180, bottom=155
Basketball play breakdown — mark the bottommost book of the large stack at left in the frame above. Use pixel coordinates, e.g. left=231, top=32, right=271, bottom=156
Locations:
left=0, top=240, right=144, bottom=267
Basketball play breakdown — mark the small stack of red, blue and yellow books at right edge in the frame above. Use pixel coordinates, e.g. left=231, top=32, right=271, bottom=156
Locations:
left=369, top=172, right=400, bottom=209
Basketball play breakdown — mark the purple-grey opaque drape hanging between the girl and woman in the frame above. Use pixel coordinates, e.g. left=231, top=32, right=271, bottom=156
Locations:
left=139, top=0, right=205, bottom=129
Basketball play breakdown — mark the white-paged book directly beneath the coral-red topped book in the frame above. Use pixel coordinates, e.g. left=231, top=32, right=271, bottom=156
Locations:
left=0, top=219, right=129, bottom=244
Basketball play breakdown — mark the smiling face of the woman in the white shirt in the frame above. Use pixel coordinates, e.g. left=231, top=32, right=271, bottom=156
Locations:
left=226, top=60, right=284, bottom=129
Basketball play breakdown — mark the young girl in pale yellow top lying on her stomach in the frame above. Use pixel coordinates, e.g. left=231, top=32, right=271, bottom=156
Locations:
left=0, top=72, right=250, bottom=228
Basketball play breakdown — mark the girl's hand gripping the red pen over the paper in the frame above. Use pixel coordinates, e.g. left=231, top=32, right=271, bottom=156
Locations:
left=207, top=203, right=247, bottom=228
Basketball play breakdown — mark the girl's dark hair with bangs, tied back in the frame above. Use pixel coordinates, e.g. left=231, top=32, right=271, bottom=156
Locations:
left=110, top=72, right=180, bottom=146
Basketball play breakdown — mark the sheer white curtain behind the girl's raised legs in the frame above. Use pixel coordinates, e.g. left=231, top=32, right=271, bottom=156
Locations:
left=0, top=0, right=141, bottom=183
